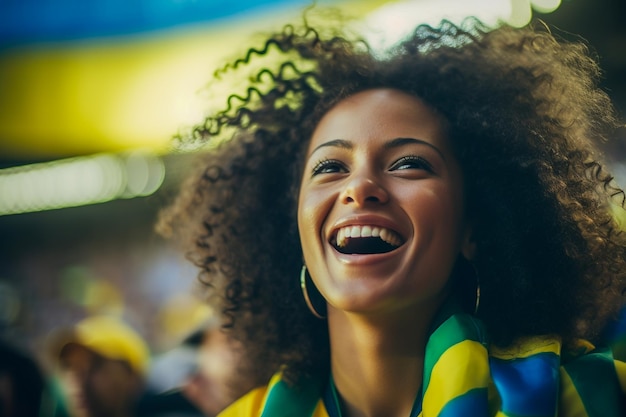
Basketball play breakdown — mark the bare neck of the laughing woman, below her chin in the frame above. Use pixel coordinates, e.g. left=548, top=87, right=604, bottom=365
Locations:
left=328, top=300, right=436, bottom=417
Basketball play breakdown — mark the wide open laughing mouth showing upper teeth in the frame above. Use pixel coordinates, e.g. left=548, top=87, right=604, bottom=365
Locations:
left=331, top=225, right=404, bottom=255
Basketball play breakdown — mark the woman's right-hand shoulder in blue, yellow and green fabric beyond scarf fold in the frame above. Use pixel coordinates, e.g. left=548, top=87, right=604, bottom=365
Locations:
left=490, top=337, right=626, bottom=417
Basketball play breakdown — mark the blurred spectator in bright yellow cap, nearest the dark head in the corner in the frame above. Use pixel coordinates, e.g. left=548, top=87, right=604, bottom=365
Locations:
left=55, top=316, right=150, bottom=417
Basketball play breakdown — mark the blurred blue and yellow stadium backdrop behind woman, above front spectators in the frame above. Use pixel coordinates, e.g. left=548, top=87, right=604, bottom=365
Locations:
left=0, top=0, right=626, bottom=364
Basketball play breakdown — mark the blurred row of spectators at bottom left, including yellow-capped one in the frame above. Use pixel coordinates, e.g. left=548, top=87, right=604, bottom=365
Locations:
left=0, top=315, right=246, bottom=417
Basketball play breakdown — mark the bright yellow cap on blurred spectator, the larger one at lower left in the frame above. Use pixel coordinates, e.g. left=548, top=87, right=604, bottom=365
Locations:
left=55, top=316, right=150, bottom=375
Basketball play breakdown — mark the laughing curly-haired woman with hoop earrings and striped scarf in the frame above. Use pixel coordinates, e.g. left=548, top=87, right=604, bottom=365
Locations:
left=161, top=14, right=626, bottom=417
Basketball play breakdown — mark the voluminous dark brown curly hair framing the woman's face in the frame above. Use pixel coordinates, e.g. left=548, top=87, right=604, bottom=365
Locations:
left=161, top=16, right=626, bottom=382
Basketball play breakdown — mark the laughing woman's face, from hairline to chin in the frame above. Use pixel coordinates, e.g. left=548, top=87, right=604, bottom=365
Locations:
left=298, top=89, right=472, bottom=313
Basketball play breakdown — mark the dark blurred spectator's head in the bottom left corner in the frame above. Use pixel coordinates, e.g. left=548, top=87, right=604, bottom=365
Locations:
left=0, top=340, right=50, bottom=417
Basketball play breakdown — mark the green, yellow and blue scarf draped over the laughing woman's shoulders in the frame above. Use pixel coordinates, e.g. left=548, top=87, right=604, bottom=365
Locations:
left=219, top=313, right=626, bottom=417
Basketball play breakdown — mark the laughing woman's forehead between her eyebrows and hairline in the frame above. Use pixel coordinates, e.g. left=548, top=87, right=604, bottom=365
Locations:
left=309, top=88, right=447, bottom=149
